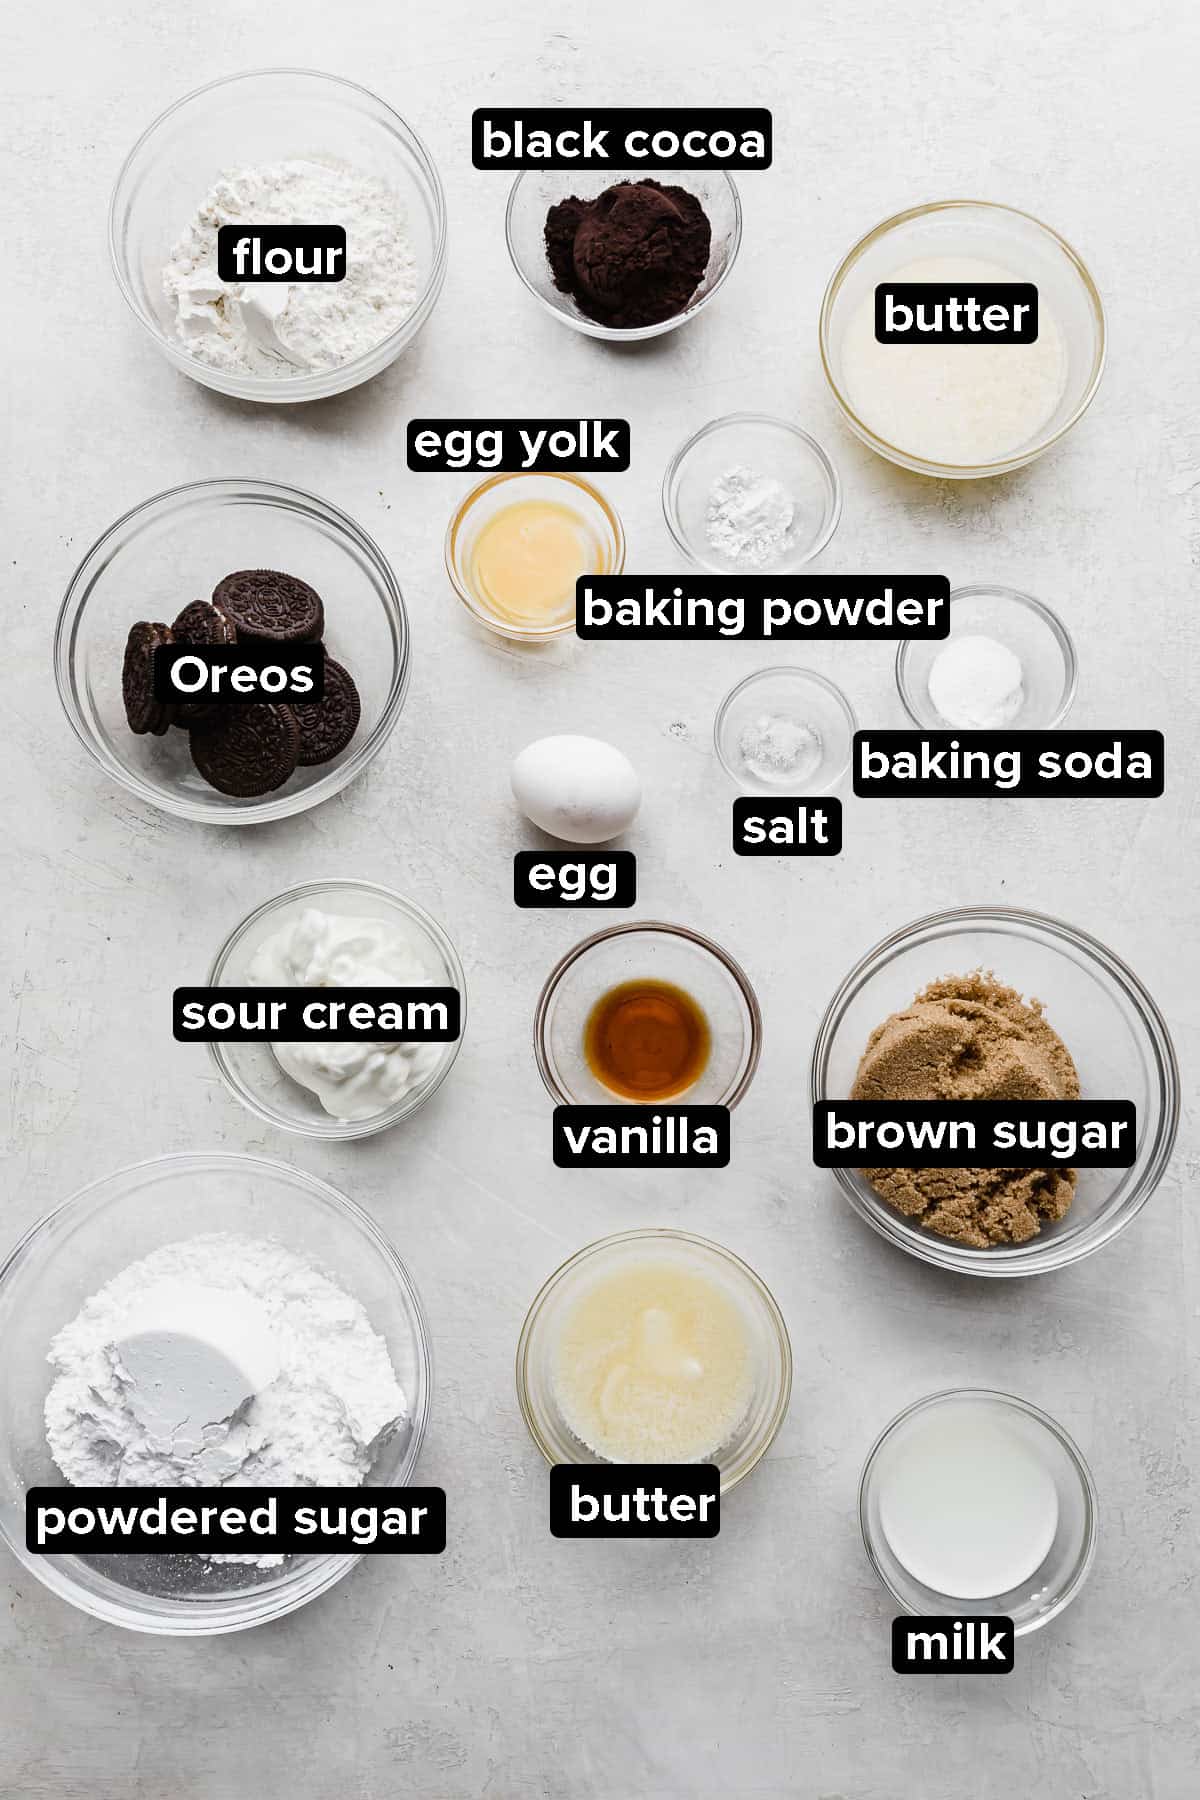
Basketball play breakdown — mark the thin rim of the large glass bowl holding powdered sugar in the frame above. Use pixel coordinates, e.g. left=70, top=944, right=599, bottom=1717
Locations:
left=0, top=1150, right=434, bottom=1638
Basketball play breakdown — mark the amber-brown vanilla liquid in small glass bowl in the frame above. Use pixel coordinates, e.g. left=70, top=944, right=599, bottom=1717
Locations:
left=583, top=981, right=712, bottom=1102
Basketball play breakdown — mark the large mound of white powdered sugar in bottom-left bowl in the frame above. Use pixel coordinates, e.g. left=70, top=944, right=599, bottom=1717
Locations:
left=45, top=1233, right=407, bottom=1562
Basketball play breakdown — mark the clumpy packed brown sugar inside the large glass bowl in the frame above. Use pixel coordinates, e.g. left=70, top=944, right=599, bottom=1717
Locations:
left=851, top=968, right=1079, bottom=1249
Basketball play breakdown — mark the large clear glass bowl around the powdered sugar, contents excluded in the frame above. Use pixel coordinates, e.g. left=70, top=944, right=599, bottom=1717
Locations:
left=0, top=1154, right=432, bottom=1636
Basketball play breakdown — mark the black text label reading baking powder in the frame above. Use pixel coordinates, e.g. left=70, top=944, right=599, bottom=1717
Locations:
left=576, top=574, right=950, bottom=643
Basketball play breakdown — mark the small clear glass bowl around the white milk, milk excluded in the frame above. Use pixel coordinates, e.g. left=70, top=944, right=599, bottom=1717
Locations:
left=858, top=1388, right=1096, bottom=1638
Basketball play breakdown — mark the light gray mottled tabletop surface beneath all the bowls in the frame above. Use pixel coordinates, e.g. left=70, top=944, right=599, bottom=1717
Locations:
left=0, top=0, right=1200, bottom=1800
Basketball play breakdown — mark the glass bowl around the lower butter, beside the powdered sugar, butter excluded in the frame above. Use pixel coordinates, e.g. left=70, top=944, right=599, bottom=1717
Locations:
left=516, top=1229, right=792, bottom=1494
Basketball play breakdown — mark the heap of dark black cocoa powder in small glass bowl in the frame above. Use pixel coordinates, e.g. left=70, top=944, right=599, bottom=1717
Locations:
left=545, top=180, right=712, bottom=329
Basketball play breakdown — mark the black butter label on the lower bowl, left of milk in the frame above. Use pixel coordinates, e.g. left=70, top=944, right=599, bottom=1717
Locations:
left=551, top=1463, right=721, bottom=1537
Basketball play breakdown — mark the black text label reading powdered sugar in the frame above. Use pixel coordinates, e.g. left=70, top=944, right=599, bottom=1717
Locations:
left=25, top=1487, right=446, bottom=1557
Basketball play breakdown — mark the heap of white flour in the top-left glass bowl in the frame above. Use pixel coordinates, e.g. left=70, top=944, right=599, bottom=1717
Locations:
left=162, top=160, right=417, bottom=378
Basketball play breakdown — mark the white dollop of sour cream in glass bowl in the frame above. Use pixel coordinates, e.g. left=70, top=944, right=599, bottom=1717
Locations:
left=246, top=907, right=446, bottom=1120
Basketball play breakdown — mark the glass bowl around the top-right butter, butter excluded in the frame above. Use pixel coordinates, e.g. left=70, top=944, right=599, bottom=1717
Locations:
left=820, top=200, right=1105, bottom=481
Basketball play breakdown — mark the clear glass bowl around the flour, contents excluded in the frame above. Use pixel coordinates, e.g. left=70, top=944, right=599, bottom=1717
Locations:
left=108, top=68, right=446, bottom=405
